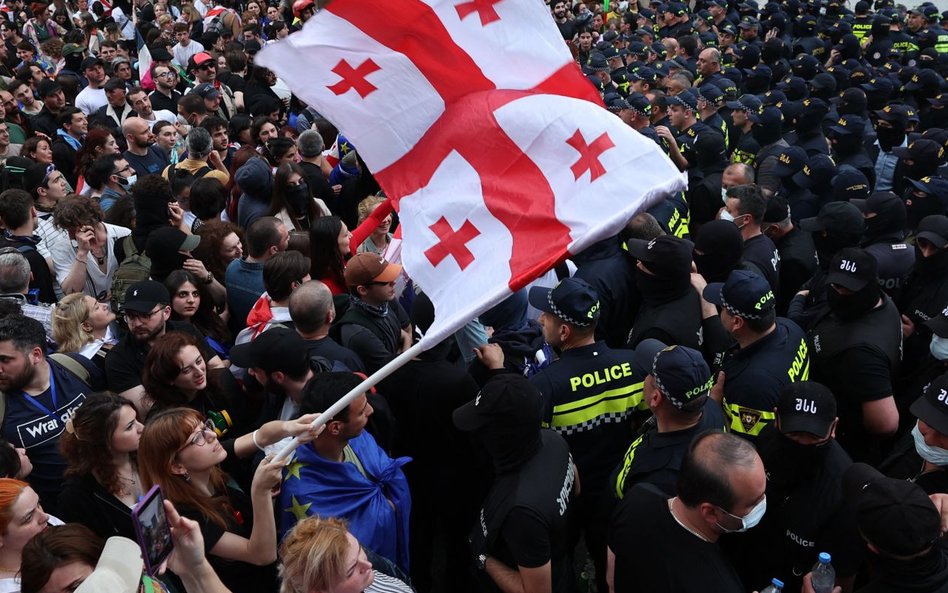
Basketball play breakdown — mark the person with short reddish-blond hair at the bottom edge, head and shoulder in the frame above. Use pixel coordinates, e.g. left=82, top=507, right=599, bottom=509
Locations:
left=280, top=517, right=413, bottom=593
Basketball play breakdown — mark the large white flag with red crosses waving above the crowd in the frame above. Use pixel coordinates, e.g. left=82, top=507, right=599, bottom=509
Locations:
left=256, top=0, right=686, bottom=345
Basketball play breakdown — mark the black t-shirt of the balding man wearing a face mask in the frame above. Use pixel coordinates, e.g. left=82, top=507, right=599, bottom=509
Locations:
left=609, top=484, right=747, bottom=593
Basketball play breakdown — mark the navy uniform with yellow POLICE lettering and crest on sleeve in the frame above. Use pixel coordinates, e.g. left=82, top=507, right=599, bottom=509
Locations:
left=721, top=318, right=810, bottom=440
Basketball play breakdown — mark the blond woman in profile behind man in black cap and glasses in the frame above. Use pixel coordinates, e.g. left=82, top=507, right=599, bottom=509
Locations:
left=52, top=292, right=118, bottom=372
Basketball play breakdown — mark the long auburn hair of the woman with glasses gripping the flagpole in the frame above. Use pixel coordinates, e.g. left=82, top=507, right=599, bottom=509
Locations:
left=138, top=408, right=230, bottom=529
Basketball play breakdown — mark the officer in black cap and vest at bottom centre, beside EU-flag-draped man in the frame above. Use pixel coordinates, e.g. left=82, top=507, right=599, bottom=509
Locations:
left=454, top=374, right=579, bottom=593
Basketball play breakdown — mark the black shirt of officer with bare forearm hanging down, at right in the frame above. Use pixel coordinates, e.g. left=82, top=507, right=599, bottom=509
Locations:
left=807, top=294, right=902, bottom=462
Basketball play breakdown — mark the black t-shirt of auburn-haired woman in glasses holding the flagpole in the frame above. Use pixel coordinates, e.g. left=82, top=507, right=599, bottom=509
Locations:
left=179, top=486, right=277, bottom=593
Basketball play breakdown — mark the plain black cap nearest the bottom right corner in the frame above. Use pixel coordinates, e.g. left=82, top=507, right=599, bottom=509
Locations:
left=843, top=463, right=941, bottom=557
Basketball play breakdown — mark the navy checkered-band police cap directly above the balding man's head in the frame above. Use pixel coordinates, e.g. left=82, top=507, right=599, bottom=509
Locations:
left=651, top=346, right=714, bottom=412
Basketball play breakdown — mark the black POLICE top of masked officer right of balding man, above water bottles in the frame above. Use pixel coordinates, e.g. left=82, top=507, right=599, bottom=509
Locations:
left=722, top=425, right=865, bottom=591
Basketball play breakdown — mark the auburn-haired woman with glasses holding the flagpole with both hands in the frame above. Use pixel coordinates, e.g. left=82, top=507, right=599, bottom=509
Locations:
left=138, top=408, right=316, bottom=593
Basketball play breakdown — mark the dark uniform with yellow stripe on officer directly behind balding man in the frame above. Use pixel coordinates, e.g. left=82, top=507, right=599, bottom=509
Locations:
left=609, top=399, right=725, bottom=499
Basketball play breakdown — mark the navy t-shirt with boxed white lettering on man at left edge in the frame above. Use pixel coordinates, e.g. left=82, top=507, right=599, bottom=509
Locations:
left=3, top=360, right=92, bottom=514
